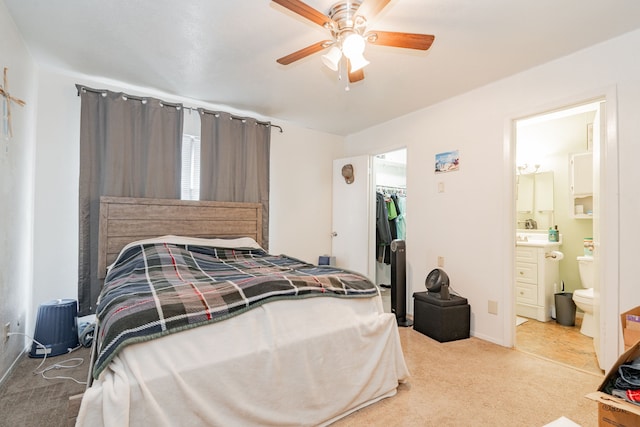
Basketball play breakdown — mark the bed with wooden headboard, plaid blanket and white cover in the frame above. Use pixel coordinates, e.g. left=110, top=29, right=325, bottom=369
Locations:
left=76, top=198, right=409, bottom=426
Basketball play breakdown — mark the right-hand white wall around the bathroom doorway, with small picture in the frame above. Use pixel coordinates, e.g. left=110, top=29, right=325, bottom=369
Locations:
left=346, top=31, right=640, bottom=372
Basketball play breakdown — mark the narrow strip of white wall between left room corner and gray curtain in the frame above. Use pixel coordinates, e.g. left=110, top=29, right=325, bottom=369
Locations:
left=32, top=69, right=80, bottom=320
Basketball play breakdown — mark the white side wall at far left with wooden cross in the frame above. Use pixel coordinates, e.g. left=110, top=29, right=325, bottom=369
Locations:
left=0, top=0, right=38, bottom=380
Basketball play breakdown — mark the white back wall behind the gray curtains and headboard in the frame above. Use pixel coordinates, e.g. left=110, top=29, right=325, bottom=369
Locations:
left=32, top=68, right=343, bottom=330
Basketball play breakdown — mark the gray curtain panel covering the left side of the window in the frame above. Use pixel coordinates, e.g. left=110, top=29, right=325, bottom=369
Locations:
left=76, top=85, right=183, bottom=316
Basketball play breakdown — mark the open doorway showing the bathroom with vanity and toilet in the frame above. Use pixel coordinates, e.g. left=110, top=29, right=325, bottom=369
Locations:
left=514, top=100, right=604, bottom=373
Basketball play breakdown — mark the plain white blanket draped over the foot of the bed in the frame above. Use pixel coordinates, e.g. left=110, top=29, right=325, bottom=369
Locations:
left=76, top=297, right=409, bottom=427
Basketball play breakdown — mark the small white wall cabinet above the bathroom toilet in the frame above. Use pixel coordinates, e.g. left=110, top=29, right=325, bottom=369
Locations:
left=569, top=152, right=593, bottom=218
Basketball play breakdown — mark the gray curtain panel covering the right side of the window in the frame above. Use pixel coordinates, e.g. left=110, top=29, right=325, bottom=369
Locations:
left=198, top=109, right=271, bottom=250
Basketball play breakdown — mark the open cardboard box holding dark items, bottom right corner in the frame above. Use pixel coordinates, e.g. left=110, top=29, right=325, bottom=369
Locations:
left=587, top=342, right=640, bottom=427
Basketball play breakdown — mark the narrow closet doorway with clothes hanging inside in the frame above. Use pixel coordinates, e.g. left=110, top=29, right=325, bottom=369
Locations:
left=372, top=148, right=407, bottom=312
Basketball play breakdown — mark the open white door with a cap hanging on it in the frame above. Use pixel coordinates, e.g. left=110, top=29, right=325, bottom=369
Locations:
left=331, top=156, right=372, bottom=279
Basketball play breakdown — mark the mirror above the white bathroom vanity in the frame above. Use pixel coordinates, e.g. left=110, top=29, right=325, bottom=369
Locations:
left=516, top=171, right=553, bottom=228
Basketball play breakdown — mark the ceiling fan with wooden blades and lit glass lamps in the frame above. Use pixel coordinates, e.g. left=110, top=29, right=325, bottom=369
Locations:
left=273, top=0, right=435, bottom=83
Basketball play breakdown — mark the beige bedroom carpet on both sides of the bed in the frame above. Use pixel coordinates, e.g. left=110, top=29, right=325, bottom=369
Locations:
left=0, top=328, right=602, bottom=427
